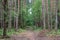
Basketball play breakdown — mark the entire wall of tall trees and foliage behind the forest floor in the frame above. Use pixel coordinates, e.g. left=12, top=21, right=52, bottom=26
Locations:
left=0, top=0, right=60, bottom=36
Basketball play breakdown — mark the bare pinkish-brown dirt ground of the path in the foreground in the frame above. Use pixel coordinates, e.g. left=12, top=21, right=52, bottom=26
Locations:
left=0, top=30, right=60, bottom=40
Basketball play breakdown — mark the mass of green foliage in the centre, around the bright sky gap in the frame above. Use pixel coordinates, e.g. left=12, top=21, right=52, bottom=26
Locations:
left=19, top=0, right=42, bottom=28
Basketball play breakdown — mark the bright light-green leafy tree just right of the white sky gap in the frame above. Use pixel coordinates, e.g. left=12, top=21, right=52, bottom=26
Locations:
left=32, top=0, right=42, bottom=21
